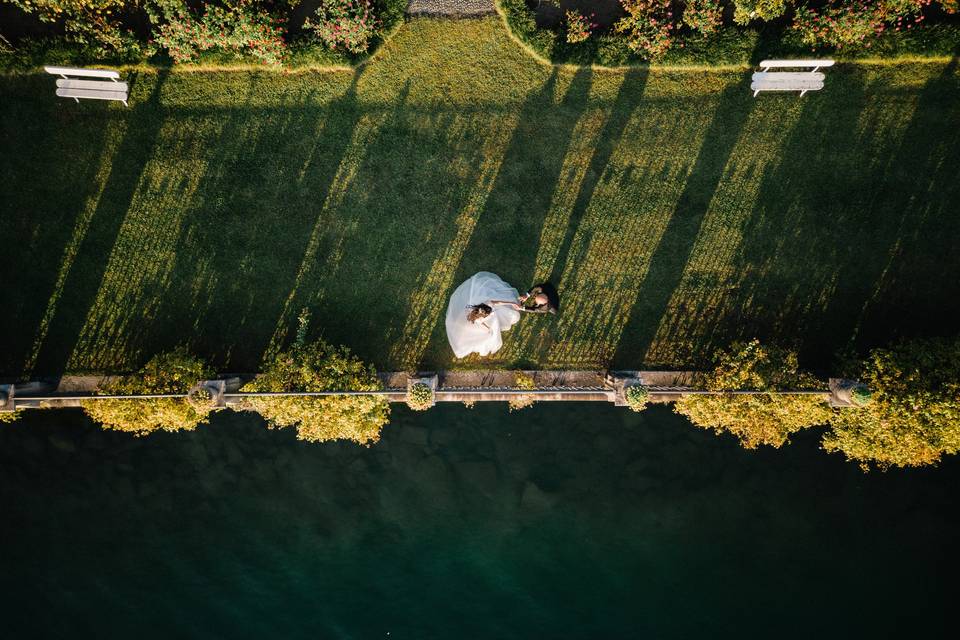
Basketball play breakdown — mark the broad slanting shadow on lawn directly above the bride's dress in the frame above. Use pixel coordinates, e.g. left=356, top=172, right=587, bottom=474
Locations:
left=459, top=68, right=592, bottom=286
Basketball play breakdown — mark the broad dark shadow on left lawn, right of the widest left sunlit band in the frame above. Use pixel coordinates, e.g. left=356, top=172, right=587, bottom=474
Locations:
left=144, top=71, right=372, bottom=370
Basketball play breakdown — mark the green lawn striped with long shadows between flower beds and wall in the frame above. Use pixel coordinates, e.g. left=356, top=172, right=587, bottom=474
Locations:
left=0, top=18, right=960, bottom=375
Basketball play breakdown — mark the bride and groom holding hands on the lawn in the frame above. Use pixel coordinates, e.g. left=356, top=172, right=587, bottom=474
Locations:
left=446, top=271, right=560, bottom=358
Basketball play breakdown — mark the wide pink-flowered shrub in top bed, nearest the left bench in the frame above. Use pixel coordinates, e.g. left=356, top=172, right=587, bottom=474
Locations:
left=156, top=0, right=285, bottom=65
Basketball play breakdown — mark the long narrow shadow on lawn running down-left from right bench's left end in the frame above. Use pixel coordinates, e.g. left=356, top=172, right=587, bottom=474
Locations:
left=614, top=75, right=754, bottom=366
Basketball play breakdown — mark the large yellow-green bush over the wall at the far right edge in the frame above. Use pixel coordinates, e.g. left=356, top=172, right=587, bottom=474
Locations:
left=823, top=339, right=960, bottom=470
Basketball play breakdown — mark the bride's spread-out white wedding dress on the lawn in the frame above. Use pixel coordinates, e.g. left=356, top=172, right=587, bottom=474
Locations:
left=447, top=271, right=520, bottom=358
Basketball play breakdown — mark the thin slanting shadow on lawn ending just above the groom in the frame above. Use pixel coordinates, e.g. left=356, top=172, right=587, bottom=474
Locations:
left=548, top=68, right=649, bottom=282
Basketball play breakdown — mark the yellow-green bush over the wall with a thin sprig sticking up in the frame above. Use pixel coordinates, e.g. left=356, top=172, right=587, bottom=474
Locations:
left=241, top=315, right=390, bottom=444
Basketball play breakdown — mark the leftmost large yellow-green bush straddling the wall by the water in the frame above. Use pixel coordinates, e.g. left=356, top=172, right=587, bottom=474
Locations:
left=83, top=347, right=213, bottom=435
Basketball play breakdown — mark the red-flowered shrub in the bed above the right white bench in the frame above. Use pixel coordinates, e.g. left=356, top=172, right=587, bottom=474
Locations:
left=793, top=0, right=931, bottom=49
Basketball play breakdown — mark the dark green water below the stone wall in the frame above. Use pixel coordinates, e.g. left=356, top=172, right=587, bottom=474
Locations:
left=0, top=403, right=960, bottom=639
